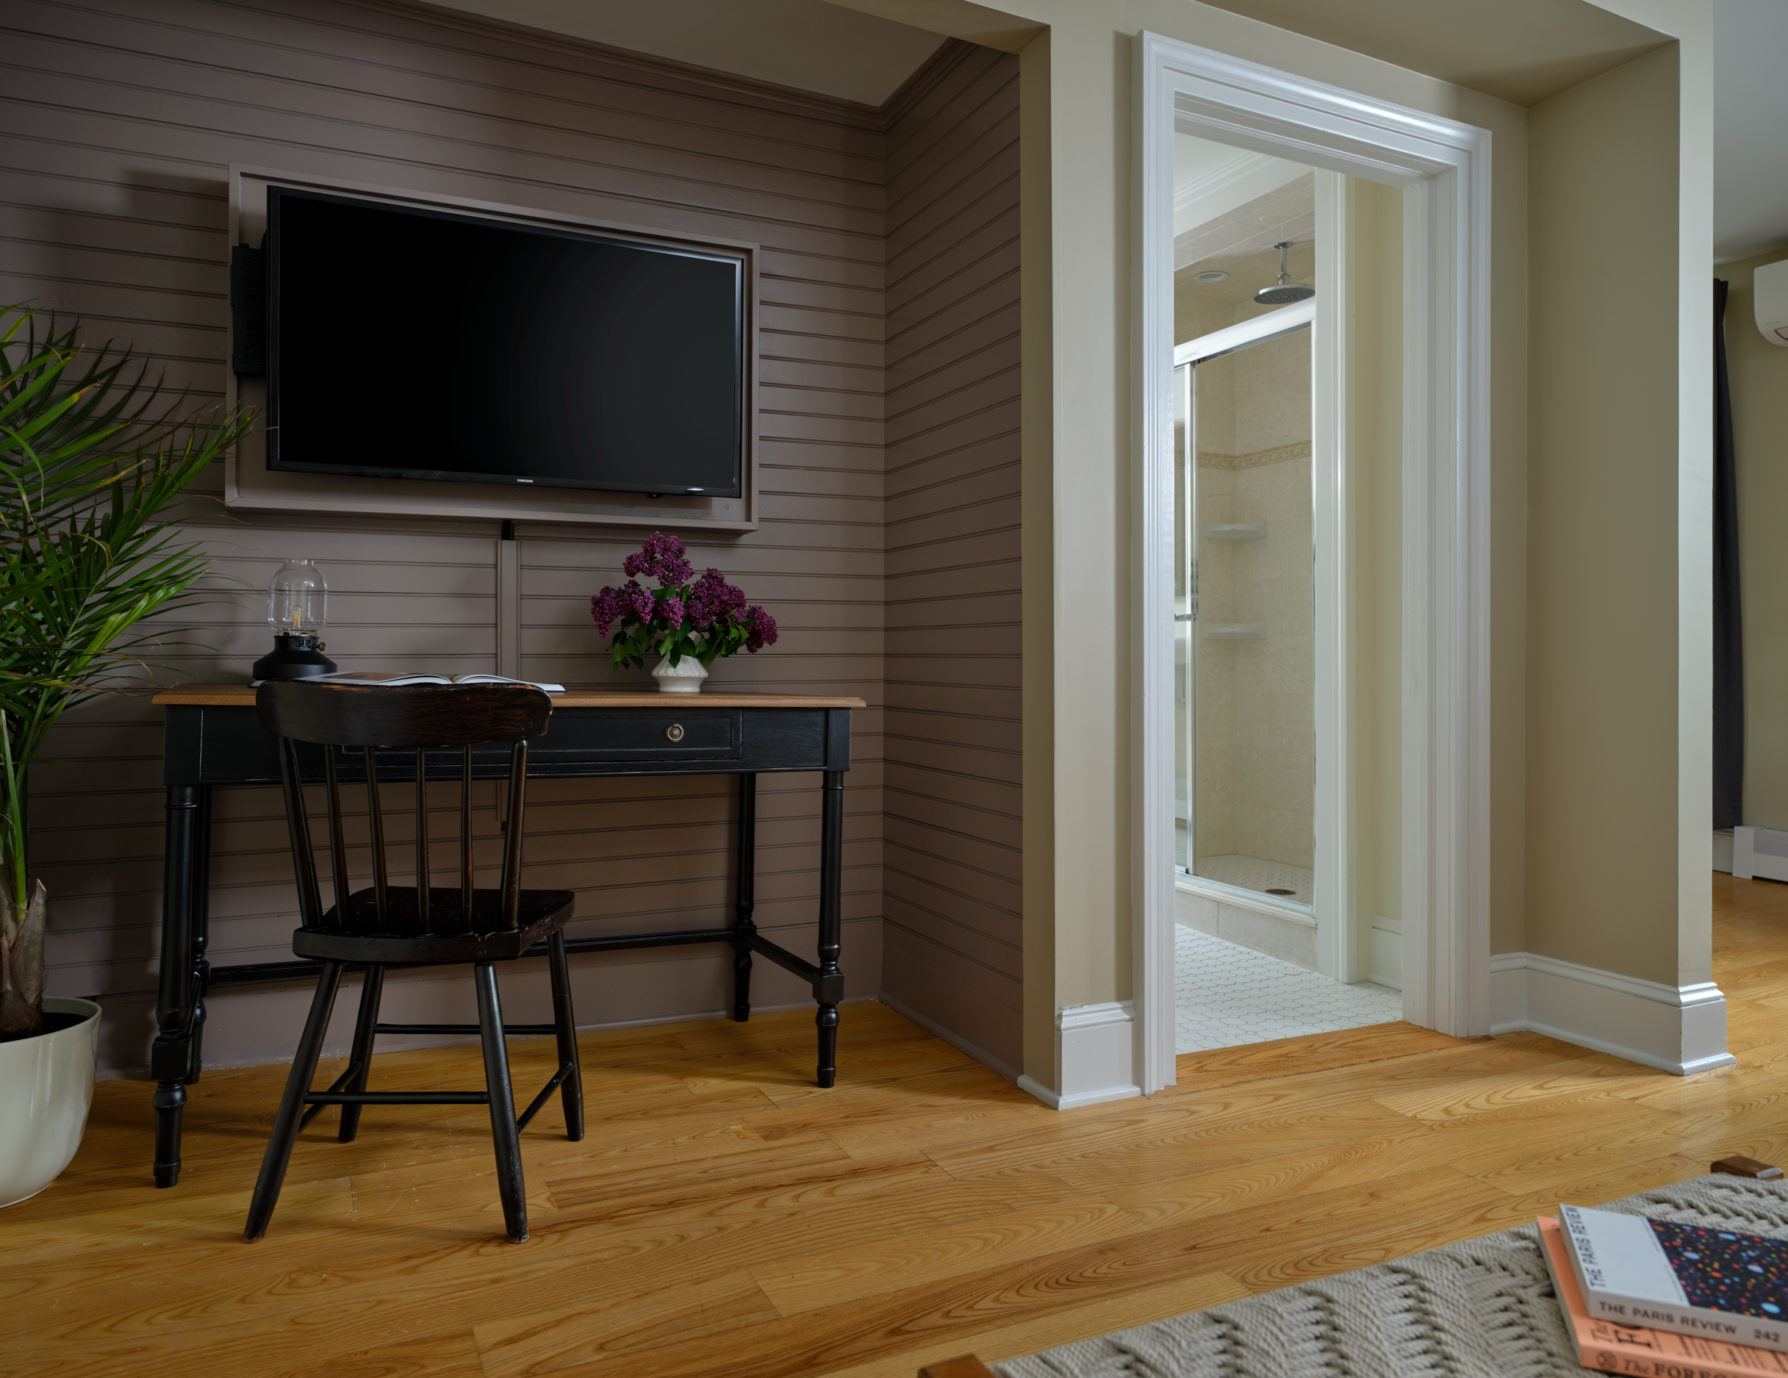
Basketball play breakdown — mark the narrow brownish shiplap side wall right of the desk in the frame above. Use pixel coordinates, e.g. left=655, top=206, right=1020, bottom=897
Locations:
left=881, top=48, right=1023, bottom=1076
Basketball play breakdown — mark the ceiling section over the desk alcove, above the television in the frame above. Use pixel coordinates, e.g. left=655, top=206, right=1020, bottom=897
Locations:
left=429, top=0, right=942, bottom=105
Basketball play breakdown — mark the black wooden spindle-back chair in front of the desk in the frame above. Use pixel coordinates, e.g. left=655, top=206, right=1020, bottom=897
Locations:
left=243, top=679, right=583, bottom=1242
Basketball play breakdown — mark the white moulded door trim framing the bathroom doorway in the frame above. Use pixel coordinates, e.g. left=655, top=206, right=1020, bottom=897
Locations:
left=1132, top=32, right=1489, bottom=1092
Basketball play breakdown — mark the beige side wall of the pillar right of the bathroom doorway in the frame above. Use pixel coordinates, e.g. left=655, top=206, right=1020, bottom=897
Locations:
left=1525, top=45, right=1711, bottom=985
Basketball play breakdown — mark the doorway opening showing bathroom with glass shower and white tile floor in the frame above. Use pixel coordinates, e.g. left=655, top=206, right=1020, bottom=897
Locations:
left=1173, top=145, right=1402, bottom=1055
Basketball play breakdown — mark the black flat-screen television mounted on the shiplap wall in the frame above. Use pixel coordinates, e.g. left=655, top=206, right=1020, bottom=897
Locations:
left=266, top=188, right=746, bottom=497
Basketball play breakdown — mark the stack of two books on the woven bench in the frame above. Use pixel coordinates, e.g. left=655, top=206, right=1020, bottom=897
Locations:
left=1539, top=1206, right=1788, bottom=1378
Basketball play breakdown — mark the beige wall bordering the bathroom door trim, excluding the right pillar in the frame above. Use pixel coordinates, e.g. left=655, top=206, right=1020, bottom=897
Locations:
left=848, top=0, right=1527, bottom=1085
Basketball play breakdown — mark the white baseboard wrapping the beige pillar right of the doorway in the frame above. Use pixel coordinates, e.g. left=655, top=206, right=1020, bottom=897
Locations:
left=1489, top=953, right=1736, bottom=1076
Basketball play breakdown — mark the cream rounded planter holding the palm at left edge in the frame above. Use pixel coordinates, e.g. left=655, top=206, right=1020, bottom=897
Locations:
left=0, top=996, right=100, bottom=1206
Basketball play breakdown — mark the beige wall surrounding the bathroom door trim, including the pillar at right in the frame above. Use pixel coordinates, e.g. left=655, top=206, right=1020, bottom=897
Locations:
left=844, top=0, right=1711, bottom=1078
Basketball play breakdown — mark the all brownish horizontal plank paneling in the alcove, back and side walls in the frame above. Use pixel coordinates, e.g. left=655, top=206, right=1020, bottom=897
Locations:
left=10, top=13, right=1021, bottom=1071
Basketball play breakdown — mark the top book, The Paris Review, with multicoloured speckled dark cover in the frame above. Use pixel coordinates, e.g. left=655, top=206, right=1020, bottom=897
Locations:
left=1559, top=1206, right=1788, bottom=1351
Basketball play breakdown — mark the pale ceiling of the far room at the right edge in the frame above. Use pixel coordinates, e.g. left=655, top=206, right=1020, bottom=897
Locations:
left=1713, top=0, right=1788, bottom=259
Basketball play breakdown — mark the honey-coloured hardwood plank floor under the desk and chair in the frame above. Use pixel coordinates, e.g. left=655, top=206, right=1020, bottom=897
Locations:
left=10, top=876, right=1788, bottom=1378
